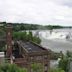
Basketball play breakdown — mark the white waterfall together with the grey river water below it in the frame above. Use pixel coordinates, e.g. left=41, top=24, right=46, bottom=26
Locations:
left=39, top=30, right=72, bottom=53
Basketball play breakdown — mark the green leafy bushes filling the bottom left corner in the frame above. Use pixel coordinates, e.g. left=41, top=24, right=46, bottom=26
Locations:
left=0, top=64, right=27, bottom=72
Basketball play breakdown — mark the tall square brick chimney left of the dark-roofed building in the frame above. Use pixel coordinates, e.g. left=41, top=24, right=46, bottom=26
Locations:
left=6, top=24, right=12, bottom=58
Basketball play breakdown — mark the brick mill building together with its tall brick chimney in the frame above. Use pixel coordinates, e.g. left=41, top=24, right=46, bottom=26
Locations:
left=6, top=25, right=50, bottom=72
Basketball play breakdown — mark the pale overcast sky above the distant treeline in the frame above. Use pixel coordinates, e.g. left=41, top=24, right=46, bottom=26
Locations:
left=0, top=0, right=72, bottom=26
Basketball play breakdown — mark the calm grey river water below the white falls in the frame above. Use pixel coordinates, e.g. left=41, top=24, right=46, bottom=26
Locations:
left=41, top=39, right=72, bottom=53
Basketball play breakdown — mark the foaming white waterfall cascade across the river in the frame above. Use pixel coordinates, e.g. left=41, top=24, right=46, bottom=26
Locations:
left=39, top=31, right=72, bottom=40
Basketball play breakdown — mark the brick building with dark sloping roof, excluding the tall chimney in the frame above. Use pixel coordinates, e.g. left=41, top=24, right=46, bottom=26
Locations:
left=12, top=40, right=50, bottom=72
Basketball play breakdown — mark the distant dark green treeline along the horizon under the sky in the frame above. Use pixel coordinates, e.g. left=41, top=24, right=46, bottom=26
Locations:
left=0, top=22, right=72, bottom=31
